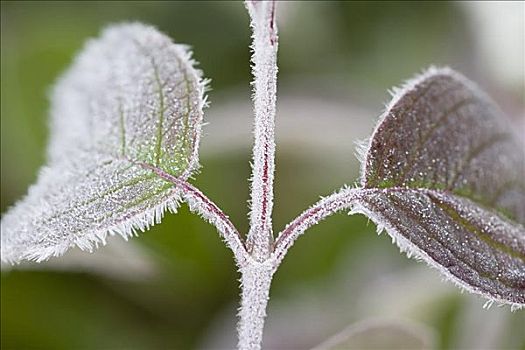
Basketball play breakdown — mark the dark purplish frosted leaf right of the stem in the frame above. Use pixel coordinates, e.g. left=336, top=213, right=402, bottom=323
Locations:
left=355, top=69, right=525, bottom=307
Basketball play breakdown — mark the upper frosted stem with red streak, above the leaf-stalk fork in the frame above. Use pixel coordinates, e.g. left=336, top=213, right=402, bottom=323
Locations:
left=246, top=0, right=277, bottom=261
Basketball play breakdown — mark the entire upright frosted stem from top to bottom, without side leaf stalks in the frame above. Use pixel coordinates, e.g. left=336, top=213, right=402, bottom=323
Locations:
left=237, top=0, right=277, bottom=350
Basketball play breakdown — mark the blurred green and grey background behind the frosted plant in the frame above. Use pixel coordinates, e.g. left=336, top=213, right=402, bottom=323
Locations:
left=0, top=1, right=525, bottom=349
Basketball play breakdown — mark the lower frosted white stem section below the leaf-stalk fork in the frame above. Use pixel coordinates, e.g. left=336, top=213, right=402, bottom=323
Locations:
left=238, top=260, right=275, bottom=350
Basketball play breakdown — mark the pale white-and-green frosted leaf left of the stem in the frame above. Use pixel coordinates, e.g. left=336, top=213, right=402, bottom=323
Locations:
left=1, top=23, right=205, bottom=262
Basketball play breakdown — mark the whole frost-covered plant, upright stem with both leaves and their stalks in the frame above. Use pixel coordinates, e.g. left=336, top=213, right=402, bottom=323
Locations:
left=1, top=5, right=525, bottom=350
